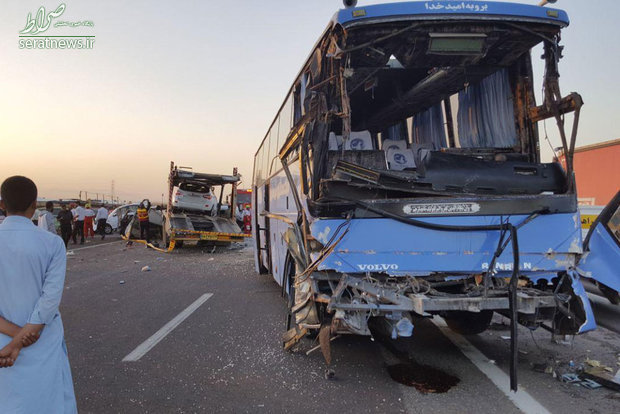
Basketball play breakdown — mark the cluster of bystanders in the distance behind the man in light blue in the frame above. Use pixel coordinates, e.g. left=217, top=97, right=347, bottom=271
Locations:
left=38, top=201, right=108, bottom=247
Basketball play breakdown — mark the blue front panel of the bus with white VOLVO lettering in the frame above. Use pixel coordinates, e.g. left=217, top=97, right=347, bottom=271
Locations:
left=311, top=213, right=582, bottom=276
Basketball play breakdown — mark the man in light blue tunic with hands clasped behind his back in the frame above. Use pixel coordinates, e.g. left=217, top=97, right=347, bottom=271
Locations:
left=0, top=176, right=77, bottom=414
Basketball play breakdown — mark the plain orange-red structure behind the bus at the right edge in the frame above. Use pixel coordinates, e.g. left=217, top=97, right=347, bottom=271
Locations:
left=561, top=139, right=620, bottom=206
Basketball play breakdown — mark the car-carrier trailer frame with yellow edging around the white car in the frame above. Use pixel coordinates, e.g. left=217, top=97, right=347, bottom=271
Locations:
left=162, top=162, right=249, bottom=250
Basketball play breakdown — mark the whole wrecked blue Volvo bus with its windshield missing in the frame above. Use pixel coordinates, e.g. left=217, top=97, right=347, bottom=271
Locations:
left=252, top=1, right=615, bottom=389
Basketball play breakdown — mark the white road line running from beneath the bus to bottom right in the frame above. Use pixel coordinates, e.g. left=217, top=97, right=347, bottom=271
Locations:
left=431, top=316, right=549, bottom=414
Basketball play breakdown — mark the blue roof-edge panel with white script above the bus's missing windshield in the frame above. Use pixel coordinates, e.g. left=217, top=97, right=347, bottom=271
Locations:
left=334, top=1, right=569, bottom=27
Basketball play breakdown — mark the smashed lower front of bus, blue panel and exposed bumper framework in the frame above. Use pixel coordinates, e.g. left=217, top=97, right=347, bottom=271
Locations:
left=290, top=210, right=595, bottom=339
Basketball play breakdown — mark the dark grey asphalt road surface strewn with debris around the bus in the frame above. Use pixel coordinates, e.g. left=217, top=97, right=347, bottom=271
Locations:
left=61, top=240, right=620, bottom=413
